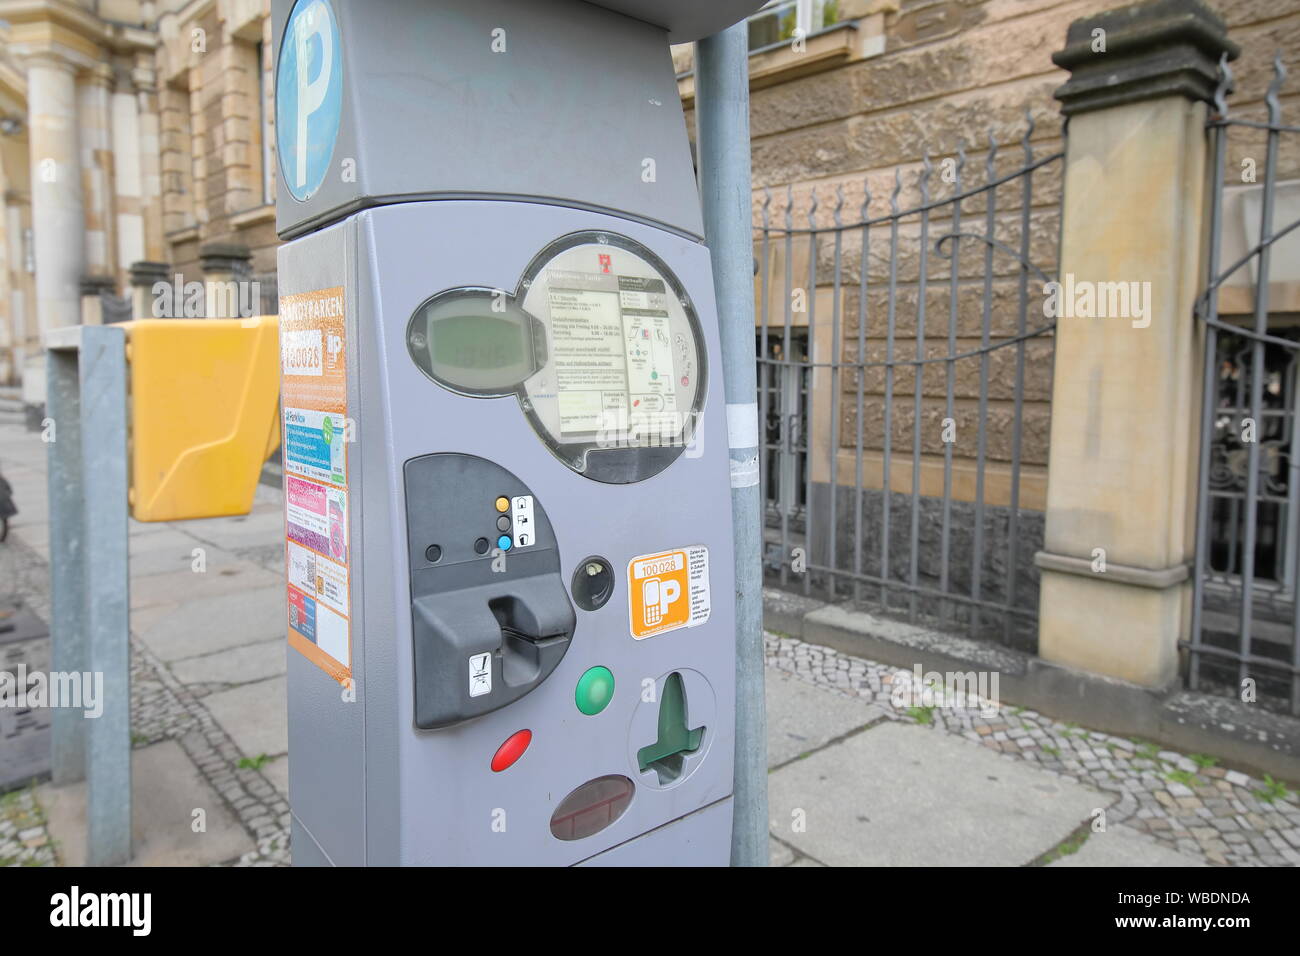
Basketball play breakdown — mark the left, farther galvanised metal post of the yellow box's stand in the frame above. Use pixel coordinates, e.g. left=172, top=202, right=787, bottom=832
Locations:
left=46, top=349, right=87, bottom=786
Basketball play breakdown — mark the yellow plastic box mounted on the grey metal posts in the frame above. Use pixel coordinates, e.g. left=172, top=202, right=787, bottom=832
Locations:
left=122, top=316, right=280, bottom=522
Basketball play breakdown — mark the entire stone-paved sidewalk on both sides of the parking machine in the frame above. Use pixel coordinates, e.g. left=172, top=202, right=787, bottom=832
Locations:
left=0, top=424, right=1300, bottom=866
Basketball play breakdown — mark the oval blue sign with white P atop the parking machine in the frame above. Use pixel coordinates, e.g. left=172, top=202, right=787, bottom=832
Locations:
left=276, top=0, right=343, bottom=200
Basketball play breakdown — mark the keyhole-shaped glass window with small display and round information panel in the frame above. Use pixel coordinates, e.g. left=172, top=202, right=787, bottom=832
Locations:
left=407, top=232, right=707, bottom=484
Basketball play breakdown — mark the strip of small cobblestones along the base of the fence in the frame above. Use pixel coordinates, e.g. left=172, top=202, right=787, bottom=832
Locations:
left=764, top=633, right=1300, bottom=866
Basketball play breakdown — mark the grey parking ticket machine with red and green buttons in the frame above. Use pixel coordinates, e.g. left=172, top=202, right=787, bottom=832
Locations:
left=273, top=0, right=761, bottom=865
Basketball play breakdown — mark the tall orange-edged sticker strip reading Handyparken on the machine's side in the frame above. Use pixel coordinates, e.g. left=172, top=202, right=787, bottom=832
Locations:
left=280, top=286, right=352, bottom=683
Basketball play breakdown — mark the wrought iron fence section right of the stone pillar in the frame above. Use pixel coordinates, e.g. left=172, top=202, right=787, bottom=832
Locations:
left=1184, top=57, right=1300, bottom=715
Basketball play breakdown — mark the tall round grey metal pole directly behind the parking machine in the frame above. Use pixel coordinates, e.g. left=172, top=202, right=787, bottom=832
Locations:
left=696, top=21, right=768, bottom=866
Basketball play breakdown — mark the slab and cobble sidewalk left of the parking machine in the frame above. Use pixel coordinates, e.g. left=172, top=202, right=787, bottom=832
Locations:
left=0, top=424, right=289, bottom=865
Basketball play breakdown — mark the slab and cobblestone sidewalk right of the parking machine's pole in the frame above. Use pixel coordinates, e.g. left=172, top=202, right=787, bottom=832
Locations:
left=766, top=635, right=1300, bottom=866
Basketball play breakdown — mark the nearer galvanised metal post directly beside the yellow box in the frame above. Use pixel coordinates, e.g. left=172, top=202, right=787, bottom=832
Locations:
left=79, top=325, right=131, bottom=866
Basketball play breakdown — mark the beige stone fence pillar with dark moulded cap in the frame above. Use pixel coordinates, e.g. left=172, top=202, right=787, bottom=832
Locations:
left=1035, top=0, right=1236, bottom=688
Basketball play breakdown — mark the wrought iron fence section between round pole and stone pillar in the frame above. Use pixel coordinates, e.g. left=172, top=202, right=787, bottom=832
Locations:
left=755, top=117, right=1062, bottom=650
